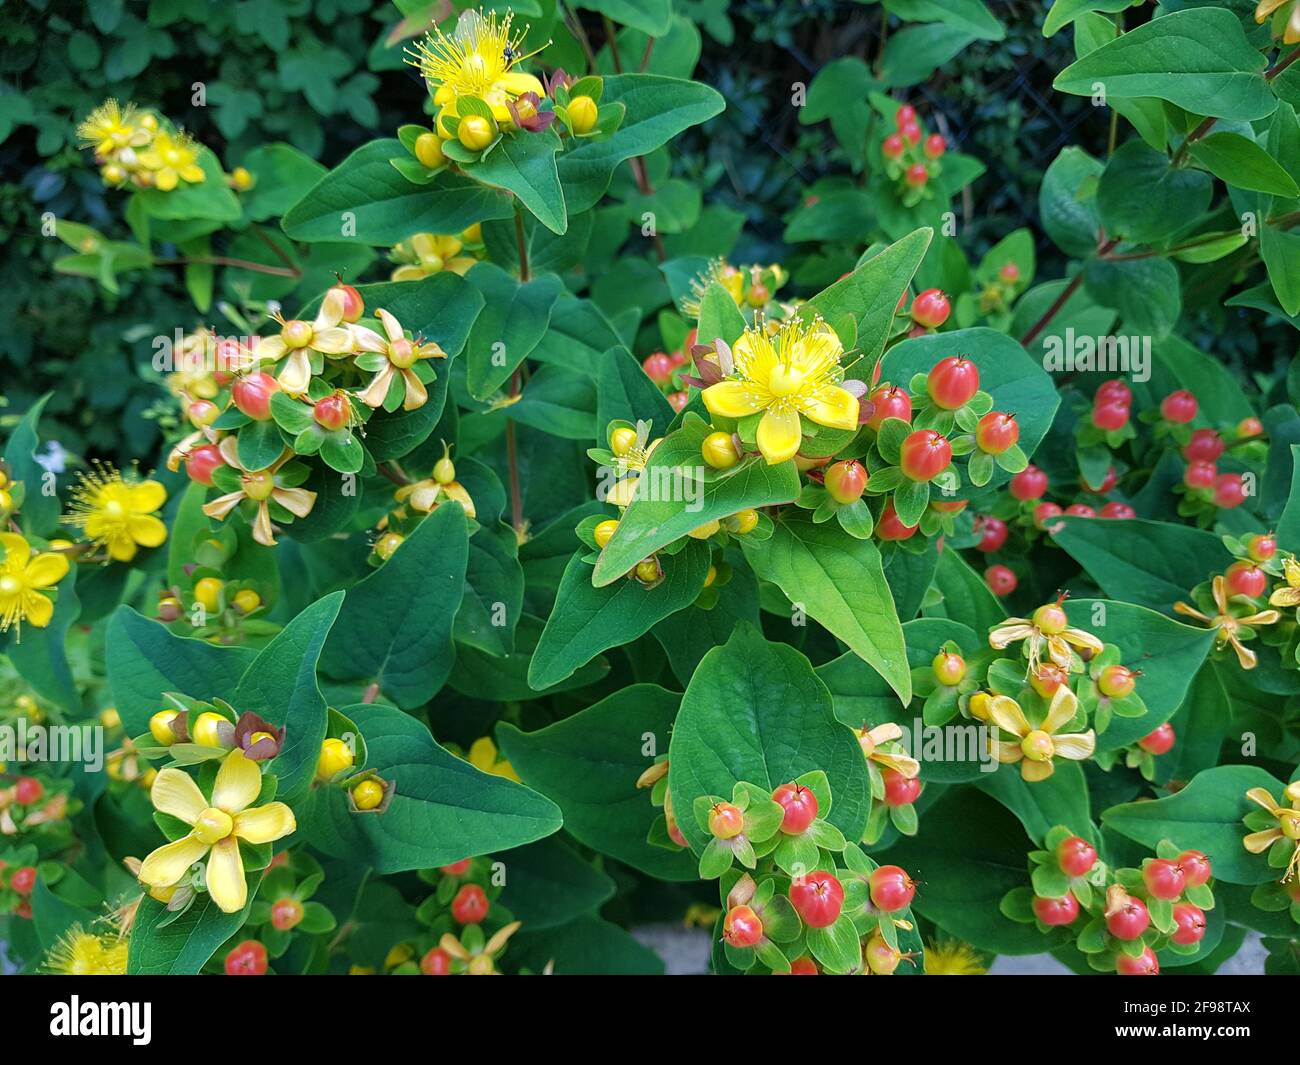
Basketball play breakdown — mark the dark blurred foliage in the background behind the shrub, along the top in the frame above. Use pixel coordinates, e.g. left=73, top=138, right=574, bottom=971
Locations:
left=0, top=0, right=1170, bottom=462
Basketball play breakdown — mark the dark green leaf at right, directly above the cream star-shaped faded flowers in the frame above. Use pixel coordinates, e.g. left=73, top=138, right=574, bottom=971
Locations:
left=1053, top=518, right=1232, bottom=611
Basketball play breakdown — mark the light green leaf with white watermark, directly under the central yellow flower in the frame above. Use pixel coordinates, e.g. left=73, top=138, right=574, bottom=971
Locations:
left=592, top=414, right=800, bottom=588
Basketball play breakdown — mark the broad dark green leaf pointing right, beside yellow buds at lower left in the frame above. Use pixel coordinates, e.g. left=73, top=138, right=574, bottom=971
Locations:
left=299, top=702, right=560, bottom=873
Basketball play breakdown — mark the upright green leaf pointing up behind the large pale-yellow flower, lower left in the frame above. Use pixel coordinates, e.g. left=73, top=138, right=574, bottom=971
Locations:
left=235, top=592, right=343, bottom=802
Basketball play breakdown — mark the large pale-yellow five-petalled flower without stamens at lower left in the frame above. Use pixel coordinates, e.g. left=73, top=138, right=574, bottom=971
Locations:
left=139, top=749, right=298, bottom=913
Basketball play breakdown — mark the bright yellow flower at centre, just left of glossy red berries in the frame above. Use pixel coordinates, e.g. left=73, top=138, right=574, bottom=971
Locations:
left=703, top=319, right=858, bottom=466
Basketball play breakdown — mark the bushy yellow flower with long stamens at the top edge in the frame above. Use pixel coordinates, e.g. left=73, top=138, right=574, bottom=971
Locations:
left=407, top=10, right=546, bottom=122
